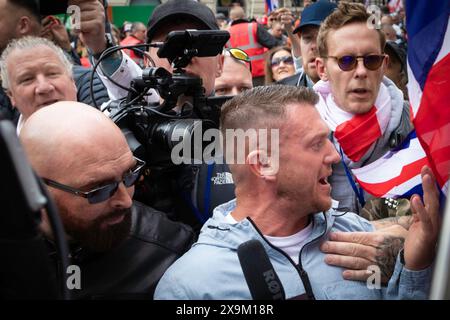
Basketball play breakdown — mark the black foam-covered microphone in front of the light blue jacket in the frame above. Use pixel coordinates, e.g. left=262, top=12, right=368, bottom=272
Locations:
left=237, top=240, right=285, bottom=300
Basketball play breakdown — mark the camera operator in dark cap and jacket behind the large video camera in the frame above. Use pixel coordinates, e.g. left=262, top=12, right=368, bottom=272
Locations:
left=79, top=0, right=234, bottom=228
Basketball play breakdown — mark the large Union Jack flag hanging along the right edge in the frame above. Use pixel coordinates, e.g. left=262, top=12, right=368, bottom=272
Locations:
left=405, top=0, right=450, bottom=194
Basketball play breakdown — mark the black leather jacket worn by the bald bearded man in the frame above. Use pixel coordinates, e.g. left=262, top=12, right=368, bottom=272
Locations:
left=50, top=201, right=195, bottom=299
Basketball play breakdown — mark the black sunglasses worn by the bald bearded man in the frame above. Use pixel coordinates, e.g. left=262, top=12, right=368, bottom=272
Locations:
left=42, top=157, right=145, bottom=204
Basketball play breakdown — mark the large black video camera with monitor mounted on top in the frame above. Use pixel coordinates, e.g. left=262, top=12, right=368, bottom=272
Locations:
left=100, top=30, right=230, bottom=168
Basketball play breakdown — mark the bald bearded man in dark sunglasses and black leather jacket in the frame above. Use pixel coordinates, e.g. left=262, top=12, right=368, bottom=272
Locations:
left=20, top=101, right=193, bottom=299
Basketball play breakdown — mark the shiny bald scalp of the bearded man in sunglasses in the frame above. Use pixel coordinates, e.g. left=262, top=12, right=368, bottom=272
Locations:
left=20, top=101, right=130, bottom=177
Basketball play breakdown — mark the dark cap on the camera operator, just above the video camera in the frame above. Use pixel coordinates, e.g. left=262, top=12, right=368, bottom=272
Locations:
left=147, top=0, right=219, bottom=42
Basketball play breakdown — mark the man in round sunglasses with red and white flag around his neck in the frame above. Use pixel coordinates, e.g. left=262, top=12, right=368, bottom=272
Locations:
left=313, top=3, right=412, bottom=280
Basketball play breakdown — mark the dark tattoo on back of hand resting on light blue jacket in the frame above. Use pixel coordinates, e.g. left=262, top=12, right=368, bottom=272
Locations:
left=375, top=237, right=405, bottom=283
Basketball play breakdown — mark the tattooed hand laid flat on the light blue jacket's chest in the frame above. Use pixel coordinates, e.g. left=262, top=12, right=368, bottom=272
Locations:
left=321, top=224, right=408, bottom=284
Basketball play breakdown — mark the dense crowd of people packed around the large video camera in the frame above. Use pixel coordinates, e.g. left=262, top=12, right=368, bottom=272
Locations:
left=0, top=0, right=440, bottom=299
